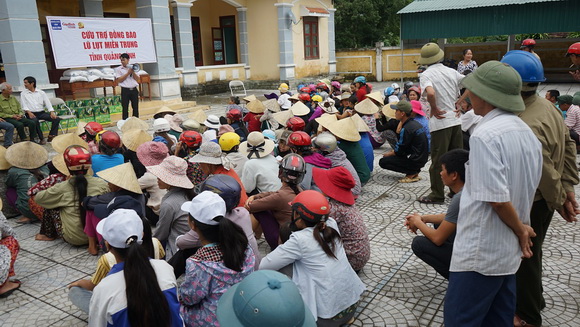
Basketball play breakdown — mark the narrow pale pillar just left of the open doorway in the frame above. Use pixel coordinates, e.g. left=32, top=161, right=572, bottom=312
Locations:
left=171, top=0, right=198, bottom=86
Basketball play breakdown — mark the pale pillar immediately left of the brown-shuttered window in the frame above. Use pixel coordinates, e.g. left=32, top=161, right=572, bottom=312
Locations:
left=274, top=3, right=296, bottom=81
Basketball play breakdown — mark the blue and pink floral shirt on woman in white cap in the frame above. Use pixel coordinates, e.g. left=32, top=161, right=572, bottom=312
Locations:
left=179, top=243, right=255, bottom=327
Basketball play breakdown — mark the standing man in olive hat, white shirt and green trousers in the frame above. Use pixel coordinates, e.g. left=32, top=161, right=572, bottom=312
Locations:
left=417, top=43, right=465, bottom=204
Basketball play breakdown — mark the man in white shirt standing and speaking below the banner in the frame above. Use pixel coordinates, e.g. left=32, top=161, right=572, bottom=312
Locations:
left=115, top=53, right=141, bottom=119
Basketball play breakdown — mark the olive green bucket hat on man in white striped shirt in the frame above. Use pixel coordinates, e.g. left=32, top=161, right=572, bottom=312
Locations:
left=461, top=60, right=526, bottom=112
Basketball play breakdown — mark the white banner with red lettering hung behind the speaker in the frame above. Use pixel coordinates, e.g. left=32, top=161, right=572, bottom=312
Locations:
left=46, top=16, right=157, bottom=69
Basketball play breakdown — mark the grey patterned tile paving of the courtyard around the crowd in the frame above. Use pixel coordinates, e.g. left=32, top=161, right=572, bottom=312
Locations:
left=0, top=83, right=580, bottom=326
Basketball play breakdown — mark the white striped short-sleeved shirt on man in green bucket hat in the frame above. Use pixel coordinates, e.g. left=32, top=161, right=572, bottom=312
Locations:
left=450, top=109, right=542, bottom=276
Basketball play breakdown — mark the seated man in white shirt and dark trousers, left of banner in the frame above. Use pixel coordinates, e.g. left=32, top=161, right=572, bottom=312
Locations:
left=20, top=76, right=60, bottom=144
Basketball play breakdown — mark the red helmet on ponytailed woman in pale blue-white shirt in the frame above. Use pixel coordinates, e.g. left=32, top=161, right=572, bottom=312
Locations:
left=290, top=190, right=330, bottom=224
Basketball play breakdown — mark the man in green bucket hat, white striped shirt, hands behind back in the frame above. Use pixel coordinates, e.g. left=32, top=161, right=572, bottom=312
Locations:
left=444, top=61, right=542, bottom=327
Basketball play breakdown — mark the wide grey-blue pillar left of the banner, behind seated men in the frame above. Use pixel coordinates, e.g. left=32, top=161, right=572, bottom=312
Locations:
left=0, top=0, right=58, bottom=97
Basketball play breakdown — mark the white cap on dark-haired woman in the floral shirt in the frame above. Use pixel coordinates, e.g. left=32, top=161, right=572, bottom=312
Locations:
left=181, top=191, right=226, bottom=226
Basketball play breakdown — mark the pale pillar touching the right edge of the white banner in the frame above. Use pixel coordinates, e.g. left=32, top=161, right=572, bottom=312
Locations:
left=135, top=0, right=181, bottom=100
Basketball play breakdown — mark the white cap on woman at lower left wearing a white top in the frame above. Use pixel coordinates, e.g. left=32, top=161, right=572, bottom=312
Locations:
left=97, top=209, right=143, bottom=249
